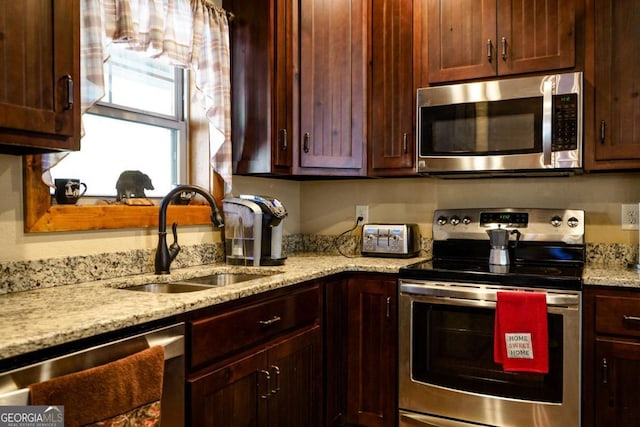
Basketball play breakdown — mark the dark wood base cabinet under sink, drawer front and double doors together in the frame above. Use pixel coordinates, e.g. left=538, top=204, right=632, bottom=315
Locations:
left=187, top=281, right=323, bottom=427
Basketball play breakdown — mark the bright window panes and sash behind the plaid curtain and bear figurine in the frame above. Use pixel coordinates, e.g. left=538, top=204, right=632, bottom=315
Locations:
left=51, top=48, right=189, bottom=198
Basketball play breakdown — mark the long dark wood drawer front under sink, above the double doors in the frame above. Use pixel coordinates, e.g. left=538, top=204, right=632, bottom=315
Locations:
left=189, top=285, right=321, bottom=369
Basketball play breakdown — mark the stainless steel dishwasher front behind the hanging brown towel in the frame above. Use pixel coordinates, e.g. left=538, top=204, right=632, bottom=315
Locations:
left=0, top=323, right=185, bottom=427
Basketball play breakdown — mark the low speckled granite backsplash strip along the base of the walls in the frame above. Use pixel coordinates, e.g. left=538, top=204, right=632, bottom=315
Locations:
left=0, top=234, right=638, bottom=294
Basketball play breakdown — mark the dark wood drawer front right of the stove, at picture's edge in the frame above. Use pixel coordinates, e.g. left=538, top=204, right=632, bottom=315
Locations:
left=596, top=296, right=640, bottom=337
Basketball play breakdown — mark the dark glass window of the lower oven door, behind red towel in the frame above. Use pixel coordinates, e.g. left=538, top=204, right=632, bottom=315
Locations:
left=411, top=302, right=563, bottom=403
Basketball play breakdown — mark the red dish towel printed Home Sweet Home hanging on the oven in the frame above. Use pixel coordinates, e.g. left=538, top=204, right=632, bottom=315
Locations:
left=493, top=292, right=549, bottom=374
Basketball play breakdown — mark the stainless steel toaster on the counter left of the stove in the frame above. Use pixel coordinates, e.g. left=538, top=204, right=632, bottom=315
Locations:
left=361, top=224, right=420, bottom=258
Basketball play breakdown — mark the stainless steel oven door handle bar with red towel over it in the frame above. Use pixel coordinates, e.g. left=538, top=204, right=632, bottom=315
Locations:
left=400, top=281, right=580, bottom=307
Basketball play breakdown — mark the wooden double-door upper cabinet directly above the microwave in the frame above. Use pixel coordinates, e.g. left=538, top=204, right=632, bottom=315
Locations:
left=427, top=0, right=576, bottom=83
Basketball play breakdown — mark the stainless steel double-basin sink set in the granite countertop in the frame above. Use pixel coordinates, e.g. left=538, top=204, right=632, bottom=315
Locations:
left=120, top=273, right=273, bottom=294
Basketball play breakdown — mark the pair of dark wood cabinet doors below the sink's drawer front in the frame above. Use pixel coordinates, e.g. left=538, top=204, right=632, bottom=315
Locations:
left=188, top=326, right=322, bottom=427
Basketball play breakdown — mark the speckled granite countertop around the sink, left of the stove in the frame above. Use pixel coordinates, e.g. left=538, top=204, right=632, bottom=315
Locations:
left=0, top=256, right=418, bottom=360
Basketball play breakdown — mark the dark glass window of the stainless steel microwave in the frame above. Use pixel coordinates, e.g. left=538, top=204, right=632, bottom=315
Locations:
left=420, top=97, right=542, bottom=156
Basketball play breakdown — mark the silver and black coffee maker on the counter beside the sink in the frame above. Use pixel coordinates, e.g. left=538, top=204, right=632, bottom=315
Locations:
left=222, top=194, right=287, bottom=266
